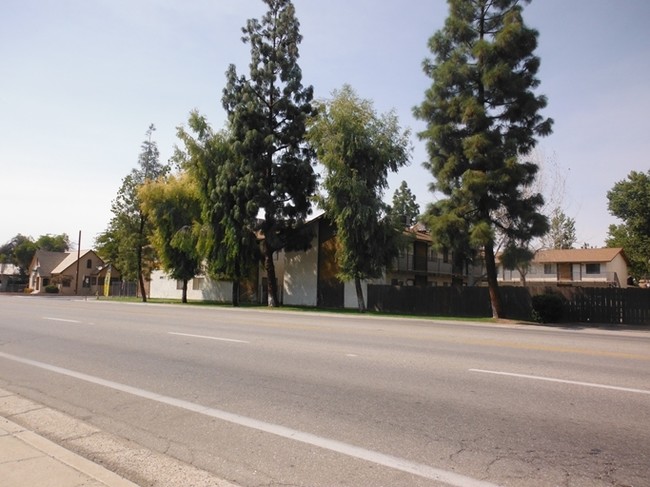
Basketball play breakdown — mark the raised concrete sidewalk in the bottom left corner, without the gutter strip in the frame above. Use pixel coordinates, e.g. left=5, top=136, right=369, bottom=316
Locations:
left=0, top=417, right=137, bottom=487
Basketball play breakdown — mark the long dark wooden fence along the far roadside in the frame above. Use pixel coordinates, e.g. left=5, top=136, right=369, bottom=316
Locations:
left=368, top=285, right=650, bottom=325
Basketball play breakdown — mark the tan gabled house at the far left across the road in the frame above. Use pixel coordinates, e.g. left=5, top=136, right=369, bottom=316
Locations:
left=29, top=250, right=120, bottom=295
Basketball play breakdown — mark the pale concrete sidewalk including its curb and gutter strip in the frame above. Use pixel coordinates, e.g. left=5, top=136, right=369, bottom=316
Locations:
left=0, top=388, right=236, bottom=487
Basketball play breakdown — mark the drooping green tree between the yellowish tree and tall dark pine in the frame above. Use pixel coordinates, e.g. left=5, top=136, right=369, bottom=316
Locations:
left=176, top=112, right=259, bottom=306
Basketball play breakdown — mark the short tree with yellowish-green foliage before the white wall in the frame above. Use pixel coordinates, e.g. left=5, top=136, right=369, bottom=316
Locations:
left=138, top=174, right=201, bottom=303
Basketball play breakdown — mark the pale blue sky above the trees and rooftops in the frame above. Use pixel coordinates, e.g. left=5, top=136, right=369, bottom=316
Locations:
left=0, top=0, right=650, bottom=247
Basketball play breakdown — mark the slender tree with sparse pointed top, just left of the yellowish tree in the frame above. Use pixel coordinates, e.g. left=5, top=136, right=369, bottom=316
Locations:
left=96, top=124, right=169, bottom=302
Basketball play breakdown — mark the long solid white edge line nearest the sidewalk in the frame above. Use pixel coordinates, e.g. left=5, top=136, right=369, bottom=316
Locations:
left=0, top=352, right=498, bottom=487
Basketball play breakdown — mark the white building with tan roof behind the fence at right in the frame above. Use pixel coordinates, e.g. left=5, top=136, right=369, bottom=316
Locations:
left=499, top=247, right=629, bottom=288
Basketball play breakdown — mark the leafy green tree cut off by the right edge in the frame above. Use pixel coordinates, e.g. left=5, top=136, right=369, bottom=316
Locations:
left=607, top=171, right=650, bottom=280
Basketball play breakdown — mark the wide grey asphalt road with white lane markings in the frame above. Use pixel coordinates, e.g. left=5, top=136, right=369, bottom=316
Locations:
left=0, top=297, right=650, bottom=487
